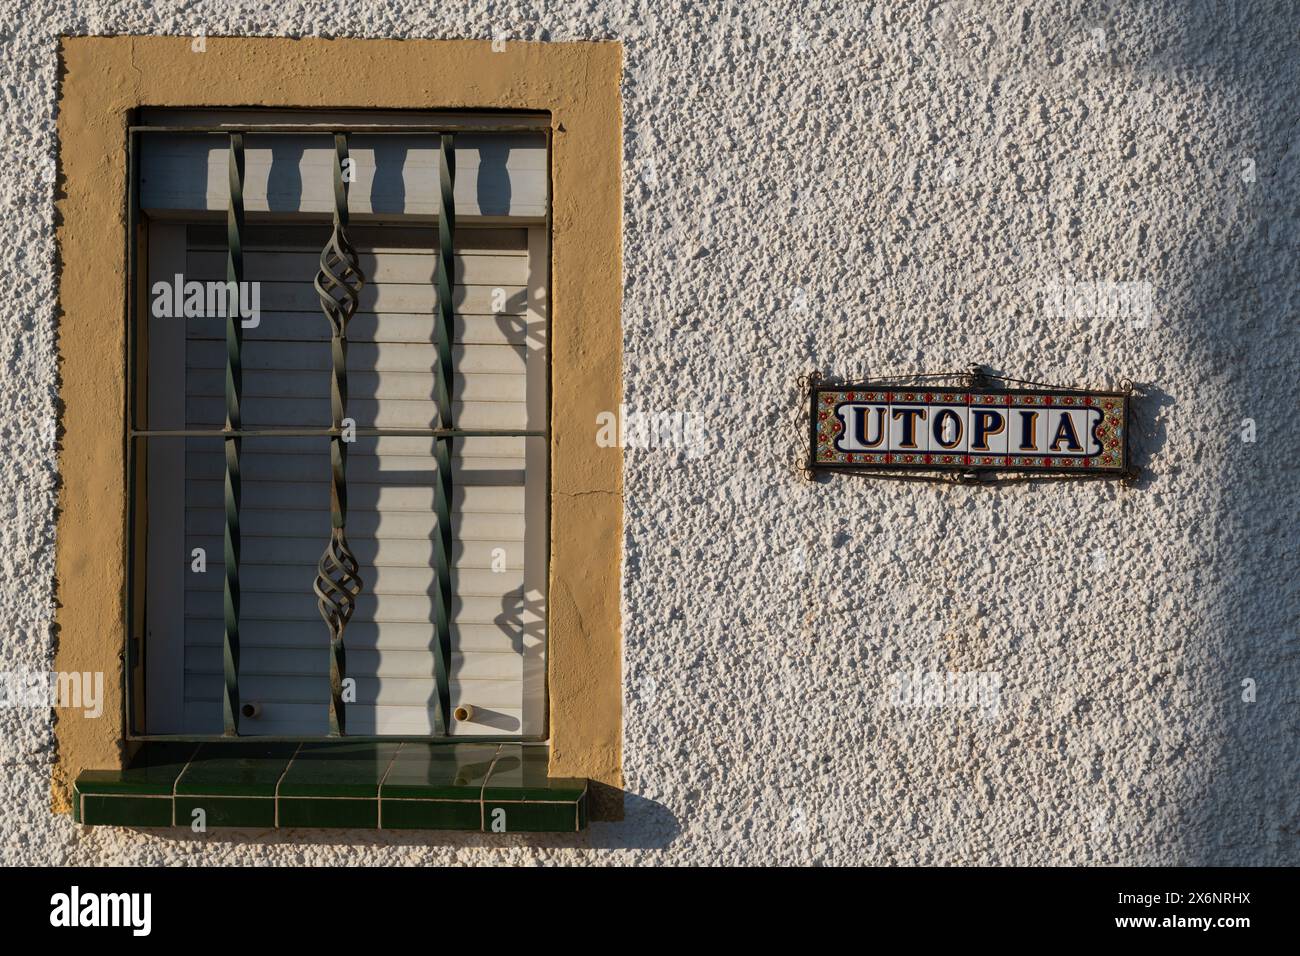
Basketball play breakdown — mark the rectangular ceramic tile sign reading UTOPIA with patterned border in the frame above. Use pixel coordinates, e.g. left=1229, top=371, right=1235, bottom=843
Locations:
left=810, top=384, right=1128, bottom=477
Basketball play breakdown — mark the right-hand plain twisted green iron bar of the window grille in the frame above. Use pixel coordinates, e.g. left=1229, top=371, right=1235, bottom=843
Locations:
left=434, top=133, right=456, bottom=734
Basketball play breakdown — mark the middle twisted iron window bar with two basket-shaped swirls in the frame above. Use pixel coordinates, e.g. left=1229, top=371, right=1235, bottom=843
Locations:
left=315, top=134, right=365, bottom=736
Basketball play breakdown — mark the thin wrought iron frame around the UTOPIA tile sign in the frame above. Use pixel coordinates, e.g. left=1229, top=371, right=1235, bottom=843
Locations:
left=800, top=364, right=1140, bottom=485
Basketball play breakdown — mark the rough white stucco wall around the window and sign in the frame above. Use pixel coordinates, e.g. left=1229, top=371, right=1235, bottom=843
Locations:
left=0, top=0, right=1300, bottom=865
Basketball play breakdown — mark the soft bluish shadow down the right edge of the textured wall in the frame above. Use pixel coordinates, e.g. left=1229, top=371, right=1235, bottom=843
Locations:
left=1121, top=0, right=1300, bottom=866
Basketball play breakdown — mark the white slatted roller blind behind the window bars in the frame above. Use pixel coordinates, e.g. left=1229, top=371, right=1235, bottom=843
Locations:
left=147, top=224, right=547, bottom=736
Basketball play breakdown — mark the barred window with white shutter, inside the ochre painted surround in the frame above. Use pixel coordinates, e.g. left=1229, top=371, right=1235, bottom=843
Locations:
left=131, top=111, right=549, bottom=739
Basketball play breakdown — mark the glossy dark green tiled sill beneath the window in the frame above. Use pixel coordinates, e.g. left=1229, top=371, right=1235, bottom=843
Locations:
left=73, top=740, right=588, bottom=832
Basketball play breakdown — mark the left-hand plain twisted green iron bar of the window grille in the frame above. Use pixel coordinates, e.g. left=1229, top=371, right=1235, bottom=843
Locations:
left=221, top=133, right=244, bottom=736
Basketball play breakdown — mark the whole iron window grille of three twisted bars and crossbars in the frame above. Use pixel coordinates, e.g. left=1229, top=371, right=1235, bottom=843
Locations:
left=127, top=125, right=546, bottom=736
